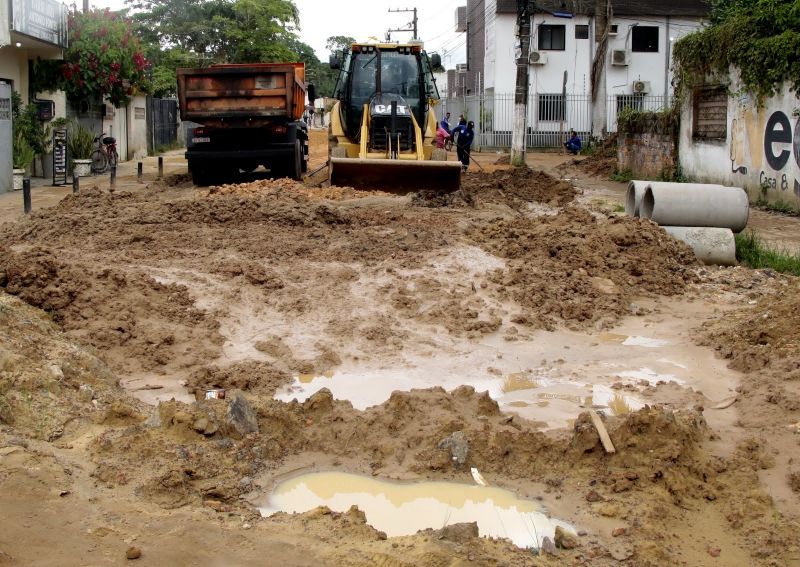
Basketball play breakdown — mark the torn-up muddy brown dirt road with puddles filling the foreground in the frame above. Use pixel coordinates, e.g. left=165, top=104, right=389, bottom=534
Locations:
left=0, top=132, right=800, bottom=566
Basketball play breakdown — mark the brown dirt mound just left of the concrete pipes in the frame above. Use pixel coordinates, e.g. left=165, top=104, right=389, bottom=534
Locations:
left=470, top=208, right=697, bottom=329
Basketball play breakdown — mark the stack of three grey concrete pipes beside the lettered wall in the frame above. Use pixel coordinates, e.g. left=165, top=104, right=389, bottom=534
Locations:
left=625, top=181, right=750, bottom=266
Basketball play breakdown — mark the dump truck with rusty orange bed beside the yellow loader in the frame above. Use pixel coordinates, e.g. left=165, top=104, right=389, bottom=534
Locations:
left=177, top=63, right=308, bottom=185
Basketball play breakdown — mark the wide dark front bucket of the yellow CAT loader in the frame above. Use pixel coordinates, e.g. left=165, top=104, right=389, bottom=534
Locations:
left=330, top=158, right=461, bottom=193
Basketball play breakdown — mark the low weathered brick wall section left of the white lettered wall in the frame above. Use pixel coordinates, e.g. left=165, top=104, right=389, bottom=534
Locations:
left=617, top=132, right=678, bottom=179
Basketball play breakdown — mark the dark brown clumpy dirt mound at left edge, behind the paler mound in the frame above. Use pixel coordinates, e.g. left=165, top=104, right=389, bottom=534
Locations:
left=0, top=247, right=222, bottom=372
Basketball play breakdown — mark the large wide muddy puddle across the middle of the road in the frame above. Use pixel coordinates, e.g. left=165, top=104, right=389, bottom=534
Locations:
left=276, top=302, right=738, bottom=429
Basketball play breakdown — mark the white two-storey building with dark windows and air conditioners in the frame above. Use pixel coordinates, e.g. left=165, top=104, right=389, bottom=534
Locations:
left=467, top=0, right=709, bottom=141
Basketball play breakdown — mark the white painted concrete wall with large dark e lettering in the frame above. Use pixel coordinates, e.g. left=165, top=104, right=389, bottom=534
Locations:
left=679, top=73, right=800, bottom=208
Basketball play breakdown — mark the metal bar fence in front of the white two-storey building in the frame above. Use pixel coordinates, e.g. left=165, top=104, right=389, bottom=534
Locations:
left=437, top=93, right=671, bottom=148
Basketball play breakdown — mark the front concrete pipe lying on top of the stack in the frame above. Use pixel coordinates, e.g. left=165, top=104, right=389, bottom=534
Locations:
left=639, top=182, right=750, bottom=232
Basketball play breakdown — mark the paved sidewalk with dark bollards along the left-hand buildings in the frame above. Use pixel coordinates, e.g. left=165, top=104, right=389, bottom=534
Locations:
left=0, top=149, right=186, bottom=223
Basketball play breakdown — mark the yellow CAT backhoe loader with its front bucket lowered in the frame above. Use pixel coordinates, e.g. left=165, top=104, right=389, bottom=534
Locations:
left=328, top=43, right=461, bottom=193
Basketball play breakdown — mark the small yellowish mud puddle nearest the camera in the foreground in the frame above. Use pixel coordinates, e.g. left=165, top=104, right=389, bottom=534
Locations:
left=261, top=472, right=575, bottom=548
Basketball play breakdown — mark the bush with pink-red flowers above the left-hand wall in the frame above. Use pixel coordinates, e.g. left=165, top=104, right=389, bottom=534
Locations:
left=60, top=8, right=150, bottom=107
